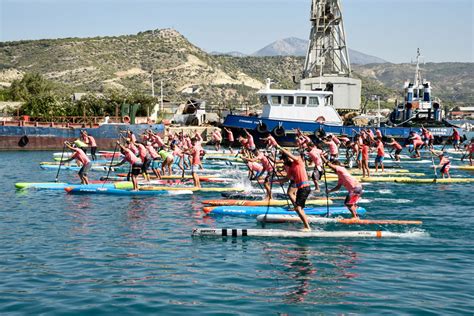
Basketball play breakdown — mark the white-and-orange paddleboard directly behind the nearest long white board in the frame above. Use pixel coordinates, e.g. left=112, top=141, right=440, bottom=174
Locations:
left=257, top=214, right=423, bottom=225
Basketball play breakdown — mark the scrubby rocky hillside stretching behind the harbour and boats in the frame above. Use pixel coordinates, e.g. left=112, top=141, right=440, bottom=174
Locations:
left=0, top=29, right=468, bottom=107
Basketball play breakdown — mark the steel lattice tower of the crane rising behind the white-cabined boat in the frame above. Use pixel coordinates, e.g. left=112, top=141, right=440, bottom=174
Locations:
left=303, top=0, right=351, bottom=78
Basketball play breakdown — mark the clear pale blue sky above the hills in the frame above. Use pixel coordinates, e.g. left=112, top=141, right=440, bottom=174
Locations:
left=0, top=0, right=474, bottom=63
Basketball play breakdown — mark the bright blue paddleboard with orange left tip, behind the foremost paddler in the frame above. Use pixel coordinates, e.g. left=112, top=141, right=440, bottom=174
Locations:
left=203, top=206, right=366, bottom=216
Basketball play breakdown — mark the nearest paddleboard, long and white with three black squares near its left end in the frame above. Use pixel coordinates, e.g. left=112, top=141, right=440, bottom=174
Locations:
left=192, top=228, right=429, bottom=238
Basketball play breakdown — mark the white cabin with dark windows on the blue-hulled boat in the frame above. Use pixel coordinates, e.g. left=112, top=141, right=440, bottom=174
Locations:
left=257, top=79, right=343, bottom=125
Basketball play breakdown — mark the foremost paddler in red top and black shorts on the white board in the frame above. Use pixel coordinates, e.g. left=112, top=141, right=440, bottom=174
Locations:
left=277, top=145, right=311, bottom=231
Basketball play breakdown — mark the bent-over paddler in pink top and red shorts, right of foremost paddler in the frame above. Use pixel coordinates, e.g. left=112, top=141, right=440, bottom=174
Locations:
left=323, top=157, right=362, bottom=219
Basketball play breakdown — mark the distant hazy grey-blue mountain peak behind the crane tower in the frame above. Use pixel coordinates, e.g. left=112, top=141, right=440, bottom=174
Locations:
left=211, top=37, right=388, bottom=65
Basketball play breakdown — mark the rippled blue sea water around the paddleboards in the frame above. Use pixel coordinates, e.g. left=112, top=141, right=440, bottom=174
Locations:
left=0, top=152, right=474, bottom=315
